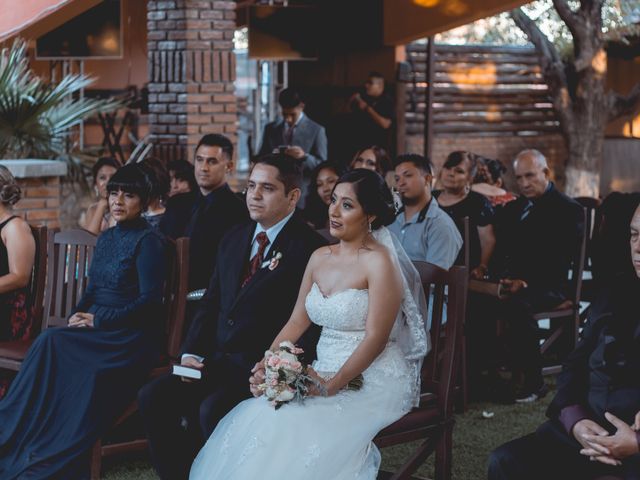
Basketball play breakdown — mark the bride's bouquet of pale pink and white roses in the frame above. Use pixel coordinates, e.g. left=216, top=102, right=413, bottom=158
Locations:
left=258, top=342, right=362, bottom=410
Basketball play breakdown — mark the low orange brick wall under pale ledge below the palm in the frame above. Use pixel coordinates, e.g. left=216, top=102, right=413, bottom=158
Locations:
left=14, top=177, right=60, bottom=228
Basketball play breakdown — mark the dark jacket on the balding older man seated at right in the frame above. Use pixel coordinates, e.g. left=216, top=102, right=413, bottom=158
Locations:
left=492, top=183, right=584, bottom=293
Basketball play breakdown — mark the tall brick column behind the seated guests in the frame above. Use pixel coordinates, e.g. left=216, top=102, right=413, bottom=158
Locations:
left=147, top=0, right=237, bottom=160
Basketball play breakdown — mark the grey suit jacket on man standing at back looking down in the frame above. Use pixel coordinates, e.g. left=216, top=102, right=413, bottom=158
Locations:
left=259, top=115, right=327, bottom=208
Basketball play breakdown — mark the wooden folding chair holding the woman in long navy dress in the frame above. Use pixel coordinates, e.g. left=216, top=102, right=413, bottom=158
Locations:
left=91, top=238, right=189, bottom=480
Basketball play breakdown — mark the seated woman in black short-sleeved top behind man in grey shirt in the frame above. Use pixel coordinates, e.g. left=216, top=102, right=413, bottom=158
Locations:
left=433, top=151, right=496, bottom=278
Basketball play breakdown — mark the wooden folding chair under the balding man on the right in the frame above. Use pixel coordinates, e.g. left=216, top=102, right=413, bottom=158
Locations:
left=533, top=209, right=588, bottom=375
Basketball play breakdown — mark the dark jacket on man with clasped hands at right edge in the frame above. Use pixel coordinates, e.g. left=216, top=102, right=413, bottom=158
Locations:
left=547, top=276, right=640, bottom=428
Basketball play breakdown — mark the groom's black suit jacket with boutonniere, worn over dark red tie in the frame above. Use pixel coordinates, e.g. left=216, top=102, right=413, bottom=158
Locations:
left=182, top=215, right=326, bottom=385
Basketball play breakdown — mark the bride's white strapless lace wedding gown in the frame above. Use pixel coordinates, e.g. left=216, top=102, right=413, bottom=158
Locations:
left=189, top=284, right=415, bottom=480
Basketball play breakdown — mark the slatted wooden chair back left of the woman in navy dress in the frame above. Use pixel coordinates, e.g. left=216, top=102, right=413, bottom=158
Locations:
left=42, top=229, right=97, bottom=329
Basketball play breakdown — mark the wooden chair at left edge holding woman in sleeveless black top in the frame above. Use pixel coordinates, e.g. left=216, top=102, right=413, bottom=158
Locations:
left=0, top=225, right=47, bottom=372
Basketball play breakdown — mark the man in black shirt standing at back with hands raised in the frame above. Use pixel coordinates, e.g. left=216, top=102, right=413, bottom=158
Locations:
left=349, top=72, right=395, bottom=153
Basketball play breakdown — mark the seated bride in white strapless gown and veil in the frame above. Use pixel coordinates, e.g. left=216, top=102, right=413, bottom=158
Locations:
left=189, top=169, right=429, bottom=480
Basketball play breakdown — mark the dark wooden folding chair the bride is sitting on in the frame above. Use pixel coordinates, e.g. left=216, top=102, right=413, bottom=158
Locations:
left=374, top=262, right=468, bottom=480
